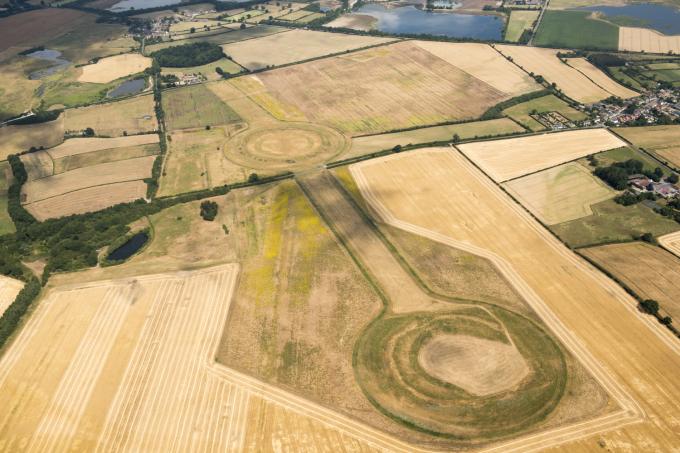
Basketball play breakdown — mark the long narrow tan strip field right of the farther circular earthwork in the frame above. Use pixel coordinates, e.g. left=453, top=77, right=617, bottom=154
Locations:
left=341, top=118, right=524, bottom=159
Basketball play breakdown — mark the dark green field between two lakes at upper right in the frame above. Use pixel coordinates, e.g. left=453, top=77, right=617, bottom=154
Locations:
left=534, top=10, right=619, bottom=50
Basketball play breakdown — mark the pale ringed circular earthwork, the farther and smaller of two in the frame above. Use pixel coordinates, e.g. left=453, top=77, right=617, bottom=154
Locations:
left=226, top=122, right=349, bottom=170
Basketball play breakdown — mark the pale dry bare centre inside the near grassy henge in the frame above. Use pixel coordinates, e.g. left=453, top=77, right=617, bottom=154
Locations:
left=418, top=334, right=529, bottom=396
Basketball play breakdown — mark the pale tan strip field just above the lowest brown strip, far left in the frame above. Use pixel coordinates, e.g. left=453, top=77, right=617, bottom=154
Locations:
left=21, top=156, right=156, bottom=204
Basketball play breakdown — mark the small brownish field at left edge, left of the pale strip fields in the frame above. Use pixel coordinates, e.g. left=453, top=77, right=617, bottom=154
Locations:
left=0, top=115, right=64, bottom=160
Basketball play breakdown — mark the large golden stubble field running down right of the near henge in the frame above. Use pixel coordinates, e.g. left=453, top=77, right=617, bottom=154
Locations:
left=351, top=148, right=680, bottom=451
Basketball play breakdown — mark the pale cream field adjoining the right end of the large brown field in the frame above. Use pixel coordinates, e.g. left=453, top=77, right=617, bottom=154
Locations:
left=416, top=41, right=542, bottom=97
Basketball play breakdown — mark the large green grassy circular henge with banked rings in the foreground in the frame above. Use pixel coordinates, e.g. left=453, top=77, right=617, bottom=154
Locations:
left=355, top=307, right=567, bottom=443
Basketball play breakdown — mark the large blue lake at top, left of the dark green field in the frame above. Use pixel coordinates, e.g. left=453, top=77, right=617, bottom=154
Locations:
left=357, top=4, right=503, bottom=40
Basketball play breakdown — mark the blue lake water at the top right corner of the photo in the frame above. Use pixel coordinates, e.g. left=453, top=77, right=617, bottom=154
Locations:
left=579, top=3, right=680, bottom=35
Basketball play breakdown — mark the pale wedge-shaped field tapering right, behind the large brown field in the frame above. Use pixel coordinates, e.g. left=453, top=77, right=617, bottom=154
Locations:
left=222, top=30, right=394, bottom=71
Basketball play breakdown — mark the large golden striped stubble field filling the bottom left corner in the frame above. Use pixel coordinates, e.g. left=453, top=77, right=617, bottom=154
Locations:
left=0, top=265, right=258, bottom=451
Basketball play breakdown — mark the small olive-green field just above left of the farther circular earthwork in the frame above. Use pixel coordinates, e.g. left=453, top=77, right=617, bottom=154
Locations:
left=163, top=84, right=241, bottom=131
